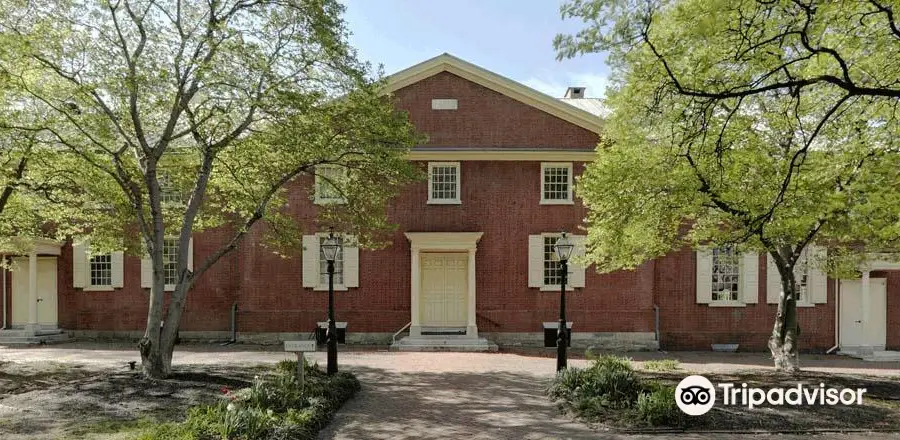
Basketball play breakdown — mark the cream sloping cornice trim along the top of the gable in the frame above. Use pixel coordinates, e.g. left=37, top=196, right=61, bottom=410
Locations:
left=385, top=53, right=603, bottom=134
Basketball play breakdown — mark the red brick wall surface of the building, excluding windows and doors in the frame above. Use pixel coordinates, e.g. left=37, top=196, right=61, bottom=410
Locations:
left=7, top=61, right=900, bottom=351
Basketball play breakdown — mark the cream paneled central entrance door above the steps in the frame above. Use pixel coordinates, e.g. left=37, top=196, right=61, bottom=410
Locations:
left=419, top=253, right=469, bottom=327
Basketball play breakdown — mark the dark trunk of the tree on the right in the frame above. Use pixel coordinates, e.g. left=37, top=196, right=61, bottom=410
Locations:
left=769, top=262, right=800, bottom=374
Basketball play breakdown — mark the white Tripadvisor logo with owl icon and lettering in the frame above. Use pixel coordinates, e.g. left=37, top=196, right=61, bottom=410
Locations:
left=675, top=376, right=866, bottom=416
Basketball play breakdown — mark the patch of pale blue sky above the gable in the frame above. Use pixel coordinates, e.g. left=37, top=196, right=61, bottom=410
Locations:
left=342, top=0, right=609, bottom=98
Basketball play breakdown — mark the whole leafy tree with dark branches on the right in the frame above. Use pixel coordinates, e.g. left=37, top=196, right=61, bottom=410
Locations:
left=555, top=0, right=900, bottom=372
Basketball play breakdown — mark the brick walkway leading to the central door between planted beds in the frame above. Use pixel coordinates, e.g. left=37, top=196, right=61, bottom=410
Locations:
left=320, top=353, right=597, bottom=440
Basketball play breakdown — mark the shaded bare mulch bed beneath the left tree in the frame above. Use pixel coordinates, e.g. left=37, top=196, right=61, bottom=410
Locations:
left=0, top=363, right=271, bottom=439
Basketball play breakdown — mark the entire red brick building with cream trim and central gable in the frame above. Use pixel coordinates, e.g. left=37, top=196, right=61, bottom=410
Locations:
left=2, top=54, right=900, bottom=358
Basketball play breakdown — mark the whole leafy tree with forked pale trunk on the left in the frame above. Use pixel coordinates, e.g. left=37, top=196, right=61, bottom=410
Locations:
left=0, top=0, right=417, bottom=377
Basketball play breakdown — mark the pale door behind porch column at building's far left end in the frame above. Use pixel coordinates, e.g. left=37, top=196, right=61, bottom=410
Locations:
left=11, top=257, right=58, bottom=328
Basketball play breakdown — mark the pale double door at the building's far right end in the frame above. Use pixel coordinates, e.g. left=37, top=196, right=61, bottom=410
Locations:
left=840, top=278, right=887, bottom=350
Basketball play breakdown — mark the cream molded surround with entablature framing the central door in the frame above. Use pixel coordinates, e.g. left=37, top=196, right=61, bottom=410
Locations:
left=404, top=232, right=484, bottom=338
